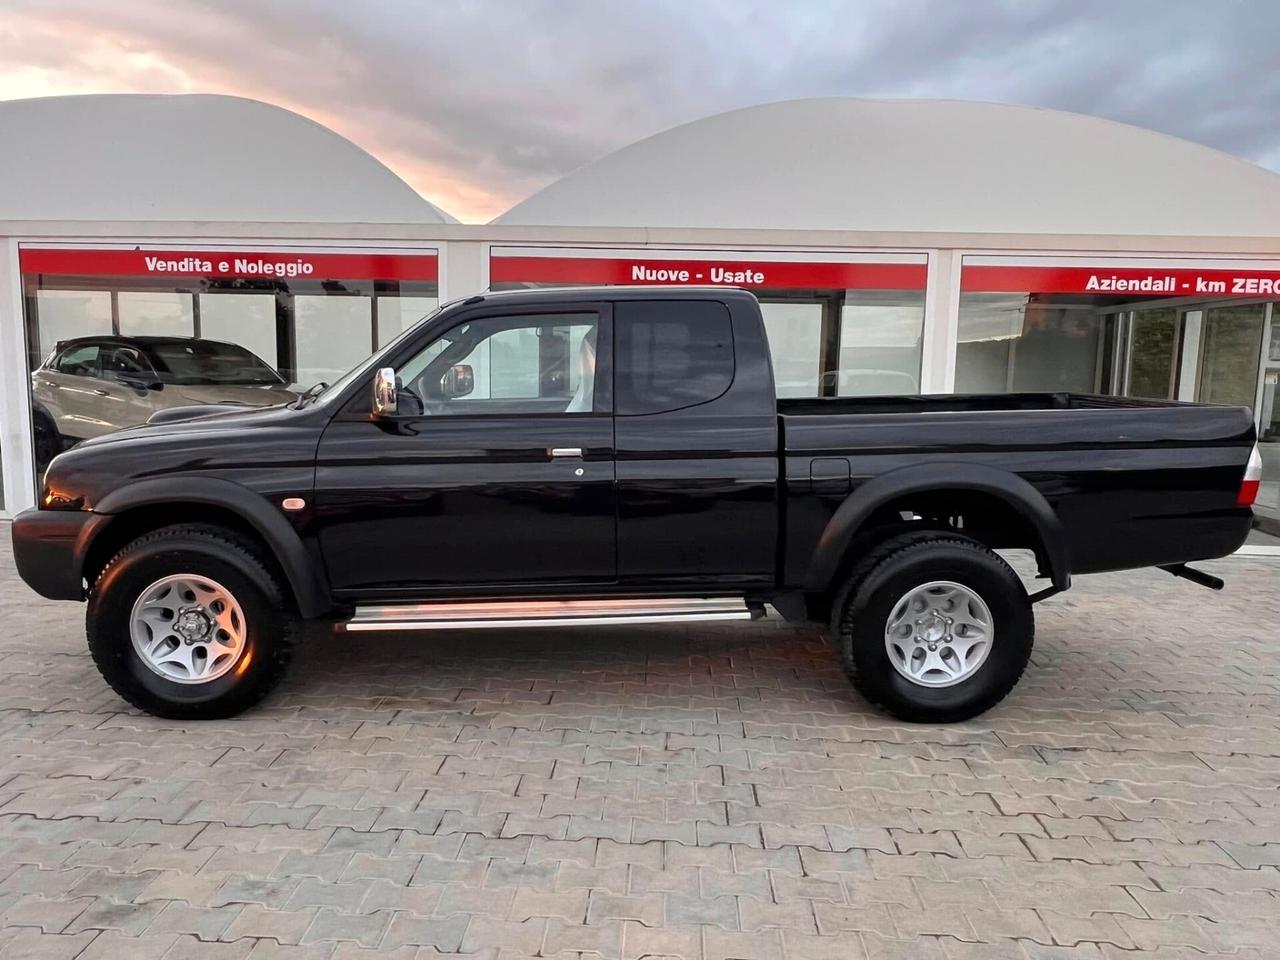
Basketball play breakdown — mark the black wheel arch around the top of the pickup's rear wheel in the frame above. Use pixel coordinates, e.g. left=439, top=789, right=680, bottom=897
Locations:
left=805, top=463, right=1071, bottom=594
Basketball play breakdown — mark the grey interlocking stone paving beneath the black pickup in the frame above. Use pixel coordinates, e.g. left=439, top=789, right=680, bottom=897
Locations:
left=0, top=527, right=1280, bottom=960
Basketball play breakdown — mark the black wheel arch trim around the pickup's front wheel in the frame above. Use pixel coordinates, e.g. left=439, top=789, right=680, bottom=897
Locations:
left=81, top=477, right=333, bottom=618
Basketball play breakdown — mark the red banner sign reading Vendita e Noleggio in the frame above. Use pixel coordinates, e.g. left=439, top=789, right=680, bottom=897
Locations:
left=18, top=247, right=439, bottom=280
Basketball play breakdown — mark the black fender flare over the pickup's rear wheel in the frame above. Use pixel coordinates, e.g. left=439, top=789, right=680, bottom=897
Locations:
left=805, top=463, right=1071, bottom=591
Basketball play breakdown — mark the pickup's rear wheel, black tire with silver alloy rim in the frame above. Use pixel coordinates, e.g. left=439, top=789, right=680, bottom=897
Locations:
left=833, top=532, right=1036, bottom=723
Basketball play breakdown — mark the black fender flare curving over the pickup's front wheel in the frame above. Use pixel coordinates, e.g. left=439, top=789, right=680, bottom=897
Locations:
left=92, top=476, right=333, bottom=620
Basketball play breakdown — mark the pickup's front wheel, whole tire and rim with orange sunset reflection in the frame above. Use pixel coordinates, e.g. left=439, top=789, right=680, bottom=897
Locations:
left=86, top=525, right=294, bottom=719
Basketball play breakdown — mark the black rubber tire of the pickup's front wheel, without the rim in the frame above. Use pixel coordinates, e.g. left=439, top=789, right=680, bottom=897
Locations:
left=84, top=525, right=297, bottom=719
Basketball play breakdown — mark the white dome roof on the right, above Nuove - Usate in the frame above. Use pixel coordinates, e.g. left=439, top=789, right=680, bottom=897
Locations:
left=495, top=99, right=1280, bottom=237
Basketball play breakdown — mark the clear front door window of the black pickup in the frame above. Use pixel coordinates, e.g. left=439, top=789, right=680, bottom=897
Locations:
left=396, top=314, right=598, bottom=416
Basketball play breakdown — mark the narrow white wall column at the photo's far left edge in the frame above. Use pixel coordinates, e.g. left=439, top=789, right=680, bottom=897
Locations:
left=0, top=239, right=36, bottom=516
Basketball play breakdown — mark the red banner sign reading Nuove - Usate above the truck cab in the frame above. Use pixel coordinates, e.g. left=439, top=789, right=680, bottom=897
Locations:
left=489, top=255, right=928, bottom=291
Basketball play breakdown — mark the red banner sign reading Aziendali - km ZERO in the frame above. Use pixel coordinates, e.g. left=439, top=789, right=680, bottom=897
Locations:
left=960, top=265, right=1280, bottom=297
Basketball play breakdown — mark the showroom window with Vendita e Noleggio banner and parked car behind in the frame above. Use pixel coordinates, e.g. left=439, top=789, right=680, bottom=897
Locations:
left=19, top=247, right=439, bottom=483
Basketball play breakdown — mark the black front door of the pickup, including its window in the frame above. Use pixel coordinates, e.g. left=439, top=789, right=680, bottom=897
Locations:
left=315, top=303, right=617, bottom=599
